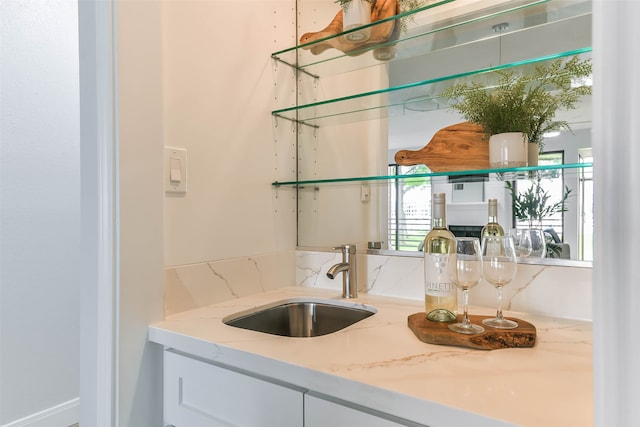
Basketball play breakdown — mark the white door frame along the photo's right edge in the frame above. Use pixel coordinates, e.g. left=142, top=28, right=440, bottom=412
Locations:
left=593, top=0, right=640, bottom=427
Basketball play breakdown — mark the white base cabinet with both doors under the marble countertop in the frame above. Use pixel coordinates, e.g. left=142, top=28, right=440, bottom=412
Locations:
left=164, top=350, right=420, bottom=427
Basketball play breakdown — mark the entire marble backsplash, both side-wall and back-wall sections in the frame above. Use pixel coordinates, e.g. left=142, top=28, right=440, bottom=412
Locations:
left=165, top=251, right=592, bottom=320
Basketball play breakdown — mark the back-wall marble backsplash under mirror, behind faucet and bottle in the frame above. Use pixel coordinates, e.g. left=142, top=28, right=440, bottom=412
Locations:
left=296, top=251, right=592, bottom=321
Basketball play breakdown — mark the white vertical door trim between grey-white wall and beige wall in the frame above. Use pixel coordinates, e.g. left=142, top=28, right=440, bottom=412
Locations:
left=78, top=1, right=117, bottom=427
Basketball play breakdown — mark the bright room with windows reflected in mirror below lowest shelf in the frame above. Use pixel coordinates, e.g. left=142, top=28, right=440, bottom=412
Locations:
left=387, top=152, right=593, bottom=261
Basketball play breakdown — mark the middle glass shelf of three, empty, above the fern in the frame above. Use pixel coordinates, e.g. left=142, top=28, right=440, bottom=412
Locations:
left=271, top=47, right=591, bottom=126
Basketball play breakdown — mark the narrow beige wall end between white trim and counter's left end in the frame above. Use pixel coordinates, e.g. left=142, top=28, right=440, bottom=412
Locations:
left=116, top=0, right=164, bottom=427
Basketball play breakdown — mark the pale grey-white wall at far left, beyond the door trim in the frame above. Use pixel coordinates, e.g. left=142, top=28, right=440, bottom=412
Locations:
left=0, top=0, right=80, bottom=426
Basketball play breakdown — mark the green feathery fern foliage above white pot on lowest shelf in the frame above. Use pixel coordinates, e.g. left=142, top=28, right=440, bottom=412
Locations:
left=443, top=56, right=592, bottom=167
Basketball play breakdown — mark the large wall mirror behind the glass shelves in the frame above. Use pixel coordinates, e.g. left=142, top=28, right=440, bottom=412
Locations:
left=297, top=0, right=593, bottom=264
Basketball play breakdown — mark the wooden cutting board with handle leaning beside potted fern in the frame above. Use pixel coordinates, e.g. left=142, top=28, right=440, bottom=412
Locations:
left=394, top=122, right=489, bottom=172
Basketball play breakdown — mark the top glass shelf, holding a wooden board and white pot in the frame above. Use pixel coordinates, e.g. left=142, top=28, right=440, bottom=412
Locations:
left=271, top=0, right=591, bottom=77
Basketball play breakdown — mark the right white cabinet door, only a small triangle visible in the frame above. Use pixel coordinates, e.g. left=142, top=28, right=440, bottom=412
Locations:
left=304, top=394, right=410, bottom=427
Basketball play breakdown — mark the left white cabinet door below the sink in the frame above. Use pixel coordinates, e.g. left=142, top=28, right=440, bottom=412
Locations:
left=164, top=351, right=303, bottom=427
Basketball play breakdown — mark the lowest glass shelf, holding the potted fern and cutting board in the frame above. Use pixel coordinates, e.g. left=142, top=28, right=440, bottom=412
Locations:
left=271, top=162, right=593, bottom=187
